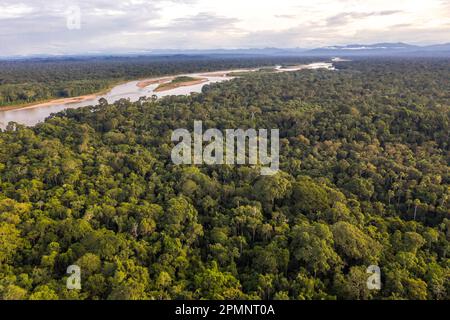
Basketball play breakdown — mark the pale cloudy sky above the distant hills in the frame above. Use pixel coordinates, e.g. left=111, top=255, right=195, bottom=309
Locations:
left=0, top=0, right=450, bottom=56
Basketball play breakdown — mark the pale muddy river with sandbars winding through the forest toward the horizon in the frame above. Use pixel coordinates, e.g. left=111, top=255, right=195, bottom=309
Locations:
left=0, top=62, right=334, bottom=129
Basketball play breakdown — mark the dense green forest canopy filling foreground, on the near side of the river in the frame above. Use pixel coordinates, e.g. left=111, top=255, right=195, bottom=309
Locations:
left=0, top=58, right=450, bottom=299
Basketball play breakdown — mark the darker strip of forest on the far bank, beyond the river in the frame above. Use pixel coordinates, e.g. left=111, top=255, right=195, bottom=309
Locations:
left=0, top=55, right=312, bottom=107
